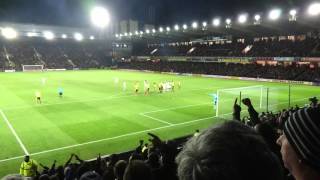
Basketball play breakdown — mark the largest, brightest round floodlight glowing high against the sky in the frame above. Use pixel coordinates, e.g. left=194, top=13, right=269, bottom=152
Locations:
left=91, top=7, right=110, bottom=28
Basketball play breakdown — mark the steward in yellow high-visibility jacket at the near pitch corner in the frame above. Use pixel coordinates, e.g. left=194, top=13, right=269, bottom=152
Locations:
left=20, top=156, right=38, bottom=177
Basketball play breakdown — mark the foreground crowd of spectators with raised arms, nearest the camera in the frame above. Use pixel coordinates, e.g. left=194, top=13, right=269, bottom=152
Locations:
left=4, top=97, right=320, bottom=180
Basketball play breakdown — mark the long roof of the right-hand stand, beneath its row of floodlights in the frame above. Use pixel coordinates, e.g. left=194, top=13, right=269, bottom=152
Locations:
left=117, top=19, right=320, bottom=43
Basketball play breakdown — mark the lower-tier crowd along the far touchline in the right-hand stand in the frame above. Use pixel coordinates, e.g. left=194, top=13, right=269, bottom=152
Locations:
left=118, top=61, right=320, bottom=82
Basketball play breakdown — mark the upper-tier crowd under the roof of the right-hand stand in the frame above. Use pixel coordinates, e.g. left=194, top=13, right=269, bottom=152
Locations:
left=133, top=38, right=320, bottom=57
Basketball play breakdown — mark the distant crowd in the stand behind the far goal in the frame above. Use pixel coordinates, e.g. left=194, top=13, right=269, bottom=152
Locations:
left=0, top=39, right=112, bottom=70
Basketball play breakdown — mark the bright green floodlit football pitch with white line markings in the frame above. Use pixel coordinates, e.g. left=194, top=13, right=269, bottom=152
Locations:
left=0, top=70, right=319, bottom=177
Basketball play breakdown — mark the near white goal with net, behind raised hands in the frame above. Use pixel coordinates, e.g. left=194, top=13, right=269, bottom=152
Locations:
left=215, top=85, right=267, bottom=117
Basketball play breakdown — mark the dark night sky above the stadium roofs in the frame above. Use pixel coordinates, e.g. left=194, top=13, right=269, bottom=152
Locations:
left=0, top=0, right=313, bottom=27
